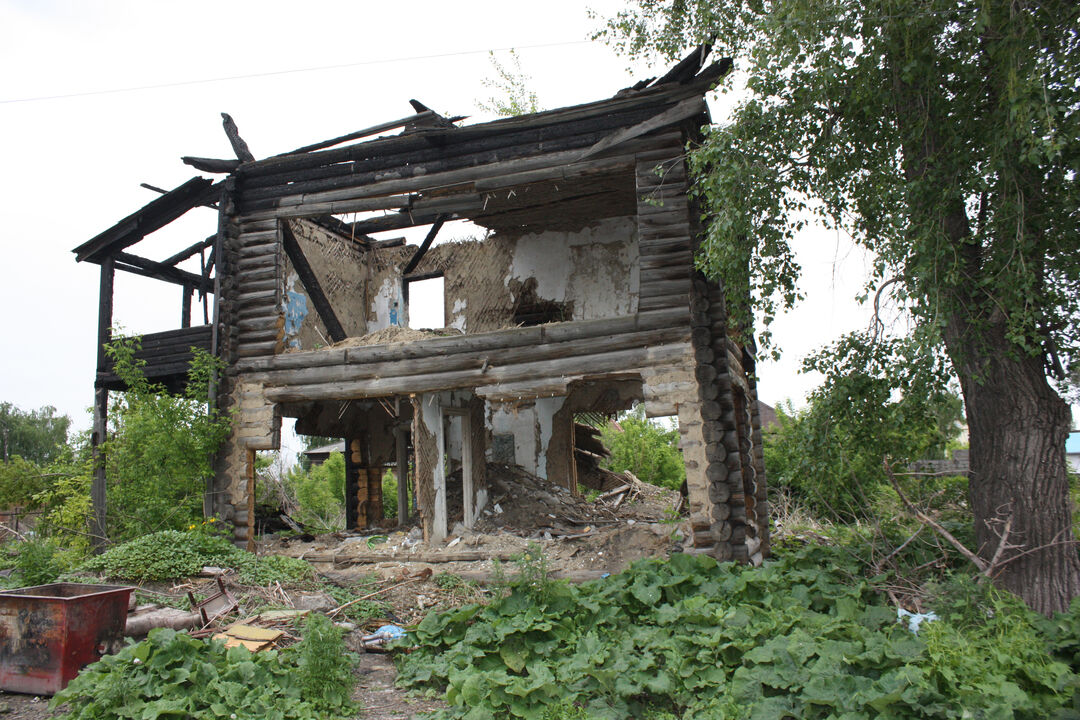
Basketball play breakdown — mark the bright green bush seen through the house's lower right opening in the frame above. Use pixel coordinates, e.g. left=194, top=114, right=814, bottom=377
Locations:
left=600, top=405, right=686, bottom=490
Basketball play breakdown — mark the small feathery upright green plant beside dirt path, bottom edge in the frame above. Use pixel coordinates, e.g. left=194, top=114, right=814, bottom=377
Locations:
left=293, top=612, right=354, bottom=711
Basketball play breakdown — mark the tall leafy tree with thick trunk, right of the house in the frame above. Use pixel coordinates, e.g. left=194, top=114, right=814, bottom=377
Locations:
left=602, top=0, right=1080, bottom=612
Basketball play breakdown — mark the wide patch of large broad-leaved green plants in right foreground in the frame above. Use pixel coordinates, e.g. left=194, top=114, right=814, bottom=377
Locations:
left=397, top=547, right=1077, bottom=720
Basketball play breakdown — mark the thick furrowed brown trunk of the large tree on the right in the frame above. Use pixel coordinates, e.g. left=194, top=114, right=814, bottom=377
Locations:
left=945, top=316, right=1080, bottom=615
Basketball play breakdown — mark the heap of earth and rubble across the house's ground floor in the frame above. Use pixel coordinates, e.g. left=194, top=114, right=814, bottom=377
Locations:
left=260, top=463, right=690, bottom=582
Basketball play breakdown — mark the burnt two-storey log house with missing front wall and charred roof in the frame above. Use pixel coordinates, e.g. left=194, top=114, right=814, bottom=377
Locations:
left=76, top=49, right=768, bottom=561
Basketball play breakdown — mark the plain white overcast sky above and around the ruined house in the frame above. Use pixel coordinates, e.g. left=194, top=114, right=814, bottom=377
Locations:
left=0, top=0, right=867, bottom=440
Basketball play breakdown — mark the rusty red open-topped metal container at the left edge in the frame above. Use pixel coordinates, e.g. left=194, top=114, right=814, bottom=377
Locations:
left=0, top=583, right=134, bottom=695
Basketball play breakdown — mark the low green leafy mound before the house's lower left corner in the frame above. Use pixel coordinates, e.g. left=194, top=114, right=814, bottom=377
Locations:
left=79, top=529, right=314, bottom=585
